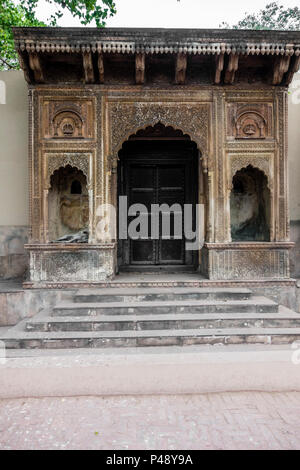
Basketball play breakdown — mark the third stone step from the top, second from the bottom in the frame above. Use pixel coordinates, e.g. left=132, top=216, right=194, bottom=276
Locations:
left=26, top=312, right=300, bottom=332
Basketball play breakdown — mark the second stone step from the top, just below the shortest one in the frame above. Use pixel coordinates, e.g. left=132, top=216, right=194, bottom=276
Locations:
left=52, top=296, right=278, bottom=316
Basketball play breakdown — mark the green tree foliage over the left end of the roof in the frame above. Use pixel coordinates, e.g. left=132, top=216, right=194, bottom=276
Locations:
left=0, top=0, right=116, bottom=70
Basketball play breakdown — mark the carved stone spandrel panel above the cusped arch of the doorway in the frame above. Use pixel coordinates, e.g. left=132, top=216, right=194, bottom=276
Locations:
left=109, top=103, right=210, bottom=167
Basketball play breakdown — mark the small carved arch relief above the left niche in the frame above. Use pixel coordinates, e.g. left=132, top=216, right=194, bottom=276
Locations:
left=52, top=109, right=83, bottom=139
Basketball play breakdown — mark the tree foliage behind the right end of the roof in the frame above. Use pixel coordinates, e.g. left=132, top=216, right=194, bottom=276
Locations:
left=220, top=2, right=300, bottom=31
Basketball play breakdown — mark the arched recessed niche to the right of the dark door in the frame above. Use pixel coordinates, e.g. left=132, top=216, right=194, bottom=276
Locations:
left=230, top=165, right=271, bottom=242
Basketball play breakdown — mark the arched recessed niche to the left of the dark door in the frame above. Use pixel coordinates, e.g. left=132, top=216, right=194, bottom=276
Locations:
left=48, top=165, right=89, bottom=241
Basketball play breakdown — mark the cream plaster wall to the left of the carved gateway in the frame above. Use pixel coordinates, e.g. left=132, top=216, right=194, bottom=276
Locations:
left=0, top=71, right=28, bottom=226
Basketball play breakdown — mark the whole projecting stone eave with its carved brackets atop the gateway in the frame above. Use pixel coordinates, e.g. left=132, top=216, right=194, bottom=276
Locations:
left=14, top=27, right=300, bottom=85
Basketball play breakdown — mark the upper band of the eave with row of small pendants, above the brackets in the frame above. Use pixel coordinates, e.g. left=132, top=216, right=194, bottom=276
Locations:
left=14, top=28, right=300, bottom=56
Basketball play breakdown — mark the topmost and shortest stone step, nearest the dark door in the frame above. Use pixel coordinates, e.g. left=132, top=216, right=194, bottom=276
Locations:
left=74, top=287, right=252, bottom=303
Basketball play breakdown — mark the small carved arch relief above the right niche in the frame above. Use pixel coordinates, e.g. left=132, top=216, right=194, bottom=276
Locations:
left=234, top=110, right=267, bottom=139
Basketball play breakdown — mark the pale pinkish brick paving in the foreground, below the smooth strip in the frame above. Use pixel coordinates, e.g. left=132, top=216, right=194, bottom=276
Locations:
left=0, top=392, right=300, bottom=450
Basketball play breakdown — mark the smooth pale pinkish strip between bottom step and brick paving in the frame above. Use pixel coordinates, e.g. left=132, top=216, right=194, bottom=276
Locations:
left=0, top=346, right=300, bottom=398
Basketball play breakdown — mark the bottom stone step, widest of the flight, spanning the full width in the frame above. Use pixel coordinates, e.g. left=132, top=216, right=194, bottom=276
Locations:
left=1, top=328, right=300, bottom=349
